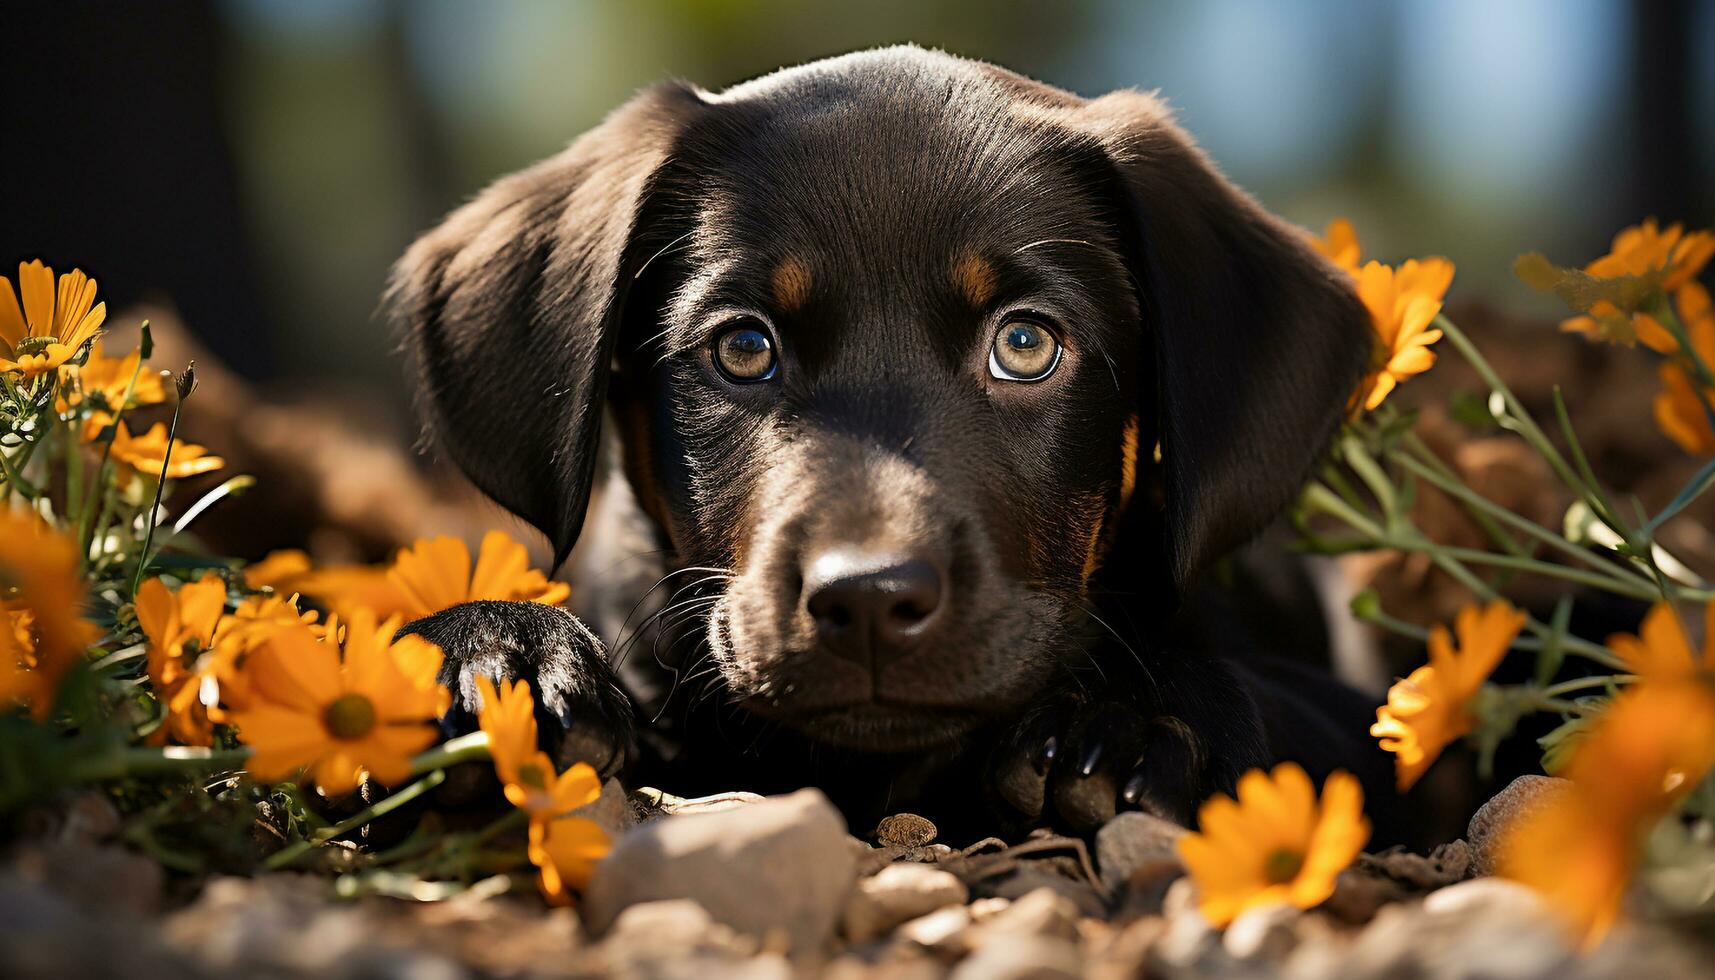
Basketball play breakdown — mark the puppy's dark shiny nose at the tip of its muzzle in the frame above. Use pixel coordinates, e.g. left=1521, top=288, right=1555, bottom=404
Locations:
left=804, top=551, right=947, bottom=664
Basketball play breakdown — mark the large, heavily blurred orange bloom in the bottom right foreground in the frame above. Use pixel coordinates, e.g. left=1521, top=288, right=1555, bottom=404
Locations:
left=1499, top=679, right=1715, bottom=949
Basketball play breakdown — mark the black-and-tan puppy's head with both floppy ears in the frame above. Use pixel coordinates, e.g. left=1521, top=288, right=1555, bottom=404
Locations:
left=394, top=48, right=1369, bottom=748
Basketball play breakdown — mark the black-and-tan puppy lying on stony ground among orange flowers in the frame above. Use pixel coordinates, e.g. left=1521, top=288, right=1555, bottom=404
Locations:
left=391, top=48, right=1413, bottom=834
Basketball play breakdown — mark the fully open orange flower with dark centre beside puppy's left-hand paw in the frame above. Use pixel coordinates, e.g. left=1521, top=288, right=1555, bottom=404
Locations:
left=232, top=609, right=451, bottom=796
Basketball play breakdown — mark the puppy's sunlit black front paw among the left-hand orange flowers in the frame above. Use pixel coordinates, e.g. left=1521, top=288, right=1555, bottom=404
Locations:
left=400, top=601, right=633, bottom=779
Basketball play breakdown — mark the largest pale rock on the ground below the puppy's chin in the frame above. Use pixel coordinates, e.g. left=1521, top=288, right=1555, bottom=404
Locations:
left=583, top=789, right=858, bottom=953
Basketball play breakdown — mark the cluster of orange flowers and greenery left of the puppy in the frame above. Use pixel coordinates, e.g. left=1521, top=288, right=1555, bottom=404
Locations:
left=0, top=261, right=609, bottom=903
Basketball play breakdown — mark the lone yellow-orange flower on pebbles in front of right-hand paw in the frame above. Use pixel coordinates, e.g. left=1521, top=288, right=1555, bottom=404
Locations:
left=1178, top=762, right=1370, bottom=927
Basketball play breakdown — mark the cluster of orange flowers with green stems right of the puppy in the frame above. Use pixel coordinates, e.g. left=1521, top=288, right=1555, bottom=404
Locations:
left=1295, top=221, right=1715, bottom=944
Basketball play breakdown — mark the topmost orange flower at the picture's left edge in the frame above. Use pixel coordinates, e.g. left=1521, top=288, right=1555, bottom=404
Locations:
left=0, top=259, right=106, bottom=379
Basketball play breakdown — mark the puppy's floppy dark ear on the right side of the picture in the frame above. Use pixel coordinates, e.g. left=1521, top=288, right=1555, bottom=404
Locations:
left=1074, top=91, right=1372, bottom=584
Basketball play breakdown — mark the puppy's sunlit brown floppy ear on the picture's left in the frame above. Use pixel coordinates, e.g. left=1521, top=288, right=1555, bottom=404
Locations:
left=388, top=84, right=703, bottom=563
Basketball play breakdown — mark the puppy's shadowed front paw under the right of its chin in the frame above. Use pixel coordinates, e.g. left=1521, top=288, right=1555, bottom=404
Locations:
left=991, top=700, right=1207, bottom=832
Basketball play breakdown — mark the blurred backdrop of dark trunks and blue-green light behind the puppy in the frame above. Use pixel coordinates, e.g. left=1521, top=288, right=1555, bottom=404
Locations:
left=0, top=0, right=1715, bottom=583
